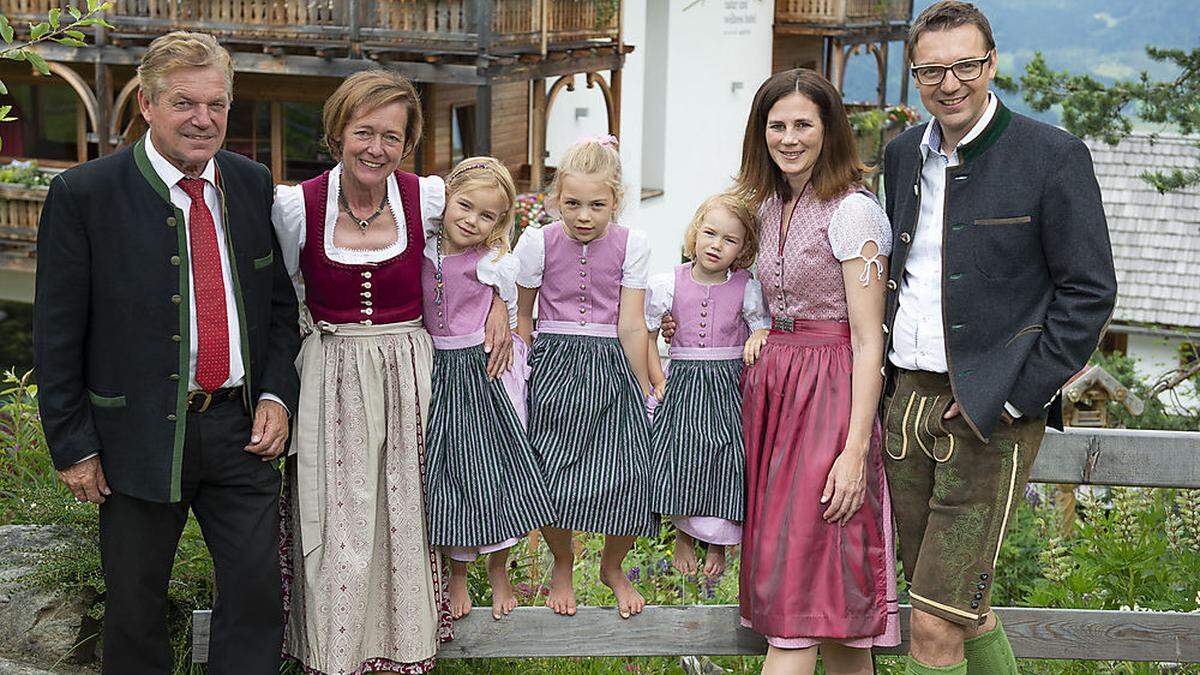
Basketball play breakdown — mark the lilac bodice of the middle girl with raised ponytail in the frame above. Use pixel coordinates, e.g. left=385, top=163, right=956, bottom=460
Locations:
left=538, top=222, right=629, bottom=335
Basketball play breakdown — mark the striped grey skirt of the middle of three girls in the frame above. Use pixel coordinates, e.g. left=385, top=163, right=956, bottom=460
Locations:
left=529, top=333, right=659, bottom=537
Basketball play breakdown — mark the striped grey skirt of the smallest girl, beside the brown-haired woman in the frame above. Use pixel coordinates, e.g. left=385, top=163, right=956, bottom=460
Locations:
left=650, top=359, right=746, bottom=521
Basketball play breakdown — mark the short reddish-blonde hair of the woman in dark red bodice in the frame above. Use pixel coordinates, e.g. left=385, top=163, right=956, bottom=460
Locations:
left=322, top=68, right=425, bottom=160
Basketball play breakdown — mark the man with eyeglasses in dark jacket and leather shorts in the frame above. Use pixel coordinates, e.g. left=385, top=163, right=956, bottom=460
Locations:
left=883, top=0, right=1116, bottom=675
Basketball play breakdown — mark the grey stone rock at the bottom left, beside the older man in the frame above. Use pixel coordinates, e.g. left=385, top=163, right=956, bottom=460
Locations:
left=0, top=525, right=100, bottom=662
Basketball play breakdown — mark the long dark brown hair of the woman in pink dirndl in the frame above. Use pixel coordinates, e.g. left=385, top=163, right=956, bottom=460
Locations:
left=734, top=68, right=870, bottom=210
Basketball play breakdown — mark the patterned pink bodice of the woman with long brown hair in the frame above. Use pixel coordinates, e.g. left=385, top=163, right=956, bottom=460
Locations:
left=756, top=186, right=856, bottom=321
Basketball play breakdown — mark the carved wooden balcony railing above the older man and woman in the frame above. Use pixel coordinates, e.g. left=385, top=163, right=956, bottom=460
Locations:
left=0, top=0, right=624, bottom=50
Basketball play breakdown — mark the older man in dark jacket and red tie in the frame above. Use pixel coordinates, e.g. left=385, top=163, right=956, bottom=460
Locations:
left=34, top=32, right=300, bottom=675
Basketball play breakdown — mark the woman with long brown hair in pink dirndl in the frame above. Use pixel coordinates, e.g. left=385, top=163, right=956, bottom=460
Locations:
left=738, top=70, right=900, bottom=674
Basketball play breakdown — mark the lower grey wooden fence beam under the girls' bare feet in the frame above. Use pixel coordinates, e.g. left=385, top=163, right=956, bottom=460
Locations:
left=192, top=605, right=1200, bottom=663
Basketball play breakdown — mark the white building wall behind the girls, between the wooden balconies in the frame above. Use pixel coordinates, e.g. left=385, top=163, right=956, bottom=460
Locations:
left=546, top=0, right=775, bottom=273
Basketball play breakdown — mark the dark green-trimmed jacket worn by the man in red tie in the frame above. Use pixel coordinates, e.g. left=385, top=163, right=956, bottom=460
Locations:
left=34, top=139, right=300, bottom=502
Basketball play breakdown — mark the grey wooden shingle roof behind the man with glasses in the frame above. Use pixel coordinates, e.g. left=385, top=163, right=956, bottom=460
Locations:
left=1087, top=135, right=1200, bottom=328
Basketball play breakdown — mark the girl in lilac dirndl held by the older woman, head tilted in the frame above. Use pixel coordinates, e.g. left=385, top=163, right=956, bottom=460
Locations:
left=421, top=157, right=554, bottom=619
